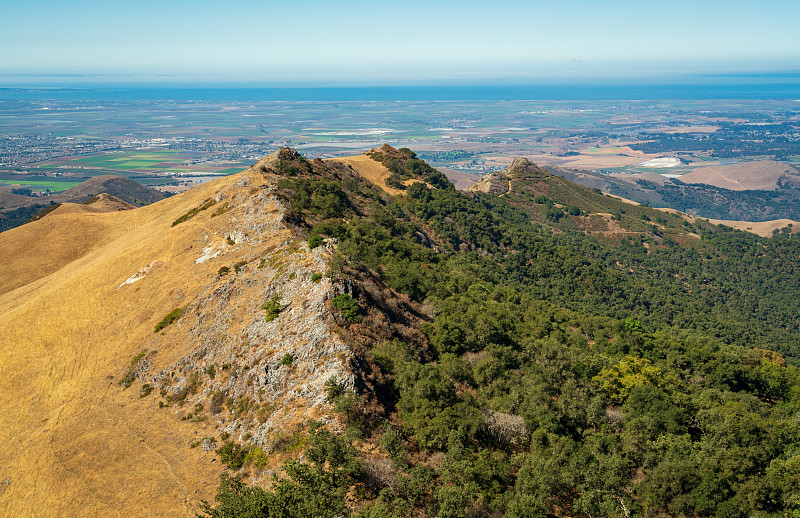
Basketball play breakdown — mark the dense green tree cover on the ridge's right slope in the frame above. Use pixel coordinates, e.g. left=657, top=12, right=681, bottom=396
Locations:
left=198, top=150, right=800, bottom=518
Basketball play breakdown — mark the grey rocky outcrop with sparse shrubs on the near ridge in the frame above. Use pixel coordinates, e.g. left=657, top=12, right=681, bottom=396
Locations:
left=121, top=156, right=356, bottom=448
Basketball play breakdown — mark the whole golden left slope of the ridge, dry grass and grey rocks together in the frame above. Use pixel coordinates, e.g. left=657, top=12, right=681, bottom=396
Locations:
left=0, top=156, right=354, bottom=517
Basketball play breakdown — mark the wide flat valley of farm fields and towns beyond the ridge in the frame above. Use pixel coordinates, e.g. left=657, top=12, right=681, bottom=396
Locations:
left=0, top=92, right=800, bottom=195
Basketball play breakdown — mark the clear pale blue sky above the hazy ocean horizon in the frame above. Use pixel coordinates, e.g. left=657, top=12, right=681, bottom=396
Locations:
left=0, top=0, right=800, bottom=84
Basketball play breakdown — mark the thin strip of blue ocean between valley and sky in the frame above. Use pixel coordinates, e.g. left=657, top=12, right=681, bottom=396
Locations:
left=0, top=74, right=800, bottom=102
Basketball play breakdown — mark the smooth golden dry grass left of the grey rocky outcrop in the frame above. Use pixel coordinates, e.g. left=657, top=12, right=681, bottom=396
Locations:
left=0, top=178, right=231, bottom=516
